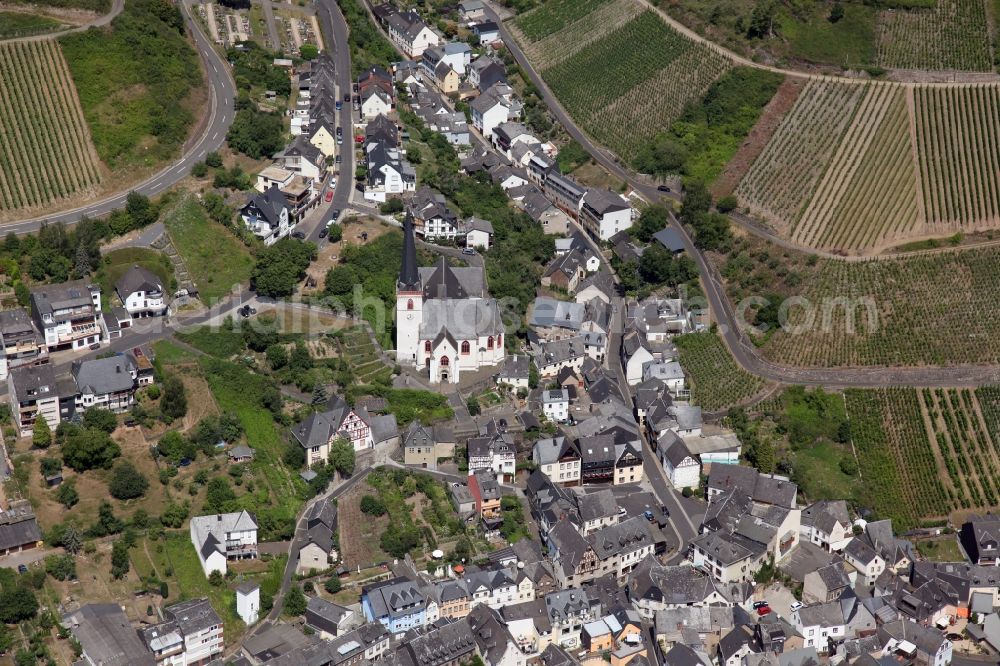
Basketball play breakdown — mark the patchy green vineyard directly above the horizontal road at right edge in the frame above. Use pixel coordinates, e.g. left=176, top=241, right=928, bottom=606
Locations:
left=715, top=232, right=1000, bottom=367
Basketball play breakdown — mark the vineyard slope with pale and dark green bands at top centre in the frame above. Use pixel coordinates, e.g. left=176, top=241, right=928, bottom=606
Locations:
left=515, top=0, right=730, bottom=160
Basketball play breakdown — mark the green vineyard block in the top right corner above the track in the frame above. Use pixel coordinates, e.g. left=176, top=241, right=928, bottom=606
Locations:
left=876, top=0, right=993, bottom=72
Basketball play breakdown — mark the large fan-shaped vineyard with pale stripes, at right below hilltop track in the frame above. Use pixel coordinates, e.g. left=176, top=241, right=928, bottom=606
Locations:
left=736, top=81, right=1000, bottom=252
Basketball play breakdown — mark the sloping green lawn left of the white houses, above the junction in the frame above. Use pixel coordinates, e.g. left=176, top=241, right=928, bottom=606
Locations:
left=163, top=197, right=254, bottom=303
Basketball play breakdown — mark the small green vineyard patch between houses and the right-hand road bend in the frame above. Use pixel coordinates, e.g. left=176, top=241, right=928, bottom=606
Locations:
left=674, top=332, right=764, bottom=411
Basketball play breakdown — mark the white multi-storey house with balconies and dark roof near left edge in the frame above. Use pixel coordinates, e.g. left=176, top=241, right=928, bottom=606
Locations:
left=30, top=280, right=103, bottom=352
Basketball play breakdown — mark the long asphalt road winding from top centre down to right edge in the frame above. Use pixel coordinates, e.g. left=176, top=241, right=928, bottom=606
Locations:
left=496, top=10, right=1000, bottom=388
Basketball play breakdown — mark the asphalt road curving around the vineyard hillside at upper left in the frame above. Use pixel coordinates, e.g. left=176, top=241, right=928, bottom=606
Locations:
left=0, top=2, right=236, bottom=234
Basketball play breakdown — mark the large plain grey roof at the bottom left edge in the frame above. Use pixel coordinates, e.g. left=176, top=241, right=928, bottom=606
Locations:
left=62, top=603, right=156, bottom=666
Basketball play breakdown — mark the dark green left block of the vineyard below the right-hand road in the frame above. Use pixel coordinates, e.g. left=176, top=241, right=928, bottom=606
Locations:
left=845, top=388, right=951, bottom=529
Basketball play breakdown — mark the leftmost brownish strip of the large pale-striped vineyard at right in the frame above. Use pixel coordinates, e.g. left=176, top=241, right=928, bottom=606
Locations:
left=736, top=81, right=864, bottom=233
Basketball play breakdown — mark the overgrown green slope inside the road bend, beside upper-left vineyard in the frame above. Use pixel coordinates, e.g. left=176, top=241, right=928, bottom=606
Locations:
left=60, top=0, right=202, bottom=169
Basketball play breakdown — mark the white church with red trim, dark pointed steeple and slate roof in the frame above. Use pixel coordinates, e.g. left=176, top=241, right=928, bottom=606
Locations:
left=396, top=215, right=504, bottom=384
